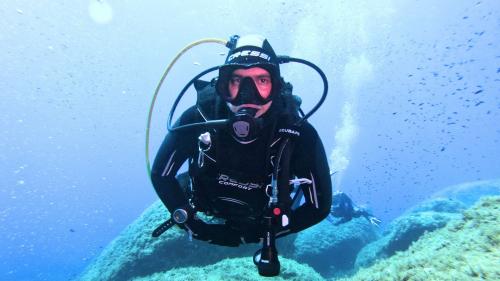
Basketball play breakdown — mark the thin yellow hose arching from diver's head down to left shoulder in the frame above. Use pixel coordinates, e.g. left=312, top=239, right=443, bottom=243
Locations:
left=146, top=38, right=227, bottom=178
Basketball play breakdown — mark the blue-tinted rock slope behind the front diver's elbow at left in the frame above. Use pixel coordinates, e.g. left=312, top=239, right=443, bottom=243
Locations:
left=79, top=201, right=262, bottom=281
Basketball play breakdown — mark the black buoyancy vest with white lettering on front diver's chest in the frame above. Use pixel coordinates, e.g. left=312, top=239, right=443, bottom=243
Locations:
left=189, top=78, right=300, bottom=222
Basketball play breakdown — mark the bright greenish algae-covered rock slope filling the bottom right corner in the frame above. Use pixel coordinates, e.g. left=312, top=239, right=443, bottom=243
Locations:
left=342, top=196, right=500, bottom=281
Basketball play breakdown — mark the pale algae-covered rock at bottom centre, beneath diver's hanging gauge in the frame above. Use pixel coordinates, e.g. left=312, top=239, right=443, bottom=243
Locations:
left=133, top=258, right=324, bottom=281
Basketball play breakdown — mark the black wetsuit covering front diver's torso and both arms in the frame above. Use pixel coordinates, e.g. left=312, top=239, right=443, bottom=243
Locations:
left=151, top=96, right=332, bottom=246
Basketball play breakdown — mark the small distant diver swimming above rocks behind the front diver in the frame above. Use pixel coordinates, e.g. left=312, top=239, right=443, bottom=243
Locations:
left=328, top=188, right=381, bottom=226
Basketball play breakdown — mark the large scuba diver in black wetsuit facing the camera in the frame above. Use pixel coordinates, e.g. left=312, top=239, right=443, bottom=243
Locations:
left=151, top=35, right=332, bottom=276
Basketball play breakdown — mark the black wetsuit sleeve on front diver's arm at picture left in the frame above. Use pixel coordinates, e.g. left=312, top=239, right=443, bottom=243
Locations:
left=151, top=108, right=197, bottom=213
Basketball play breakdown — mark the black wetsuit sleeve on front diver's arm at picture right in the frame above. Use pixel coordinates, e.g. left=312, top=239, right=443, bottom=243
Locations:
left=290, top=123, right=332, bottom=235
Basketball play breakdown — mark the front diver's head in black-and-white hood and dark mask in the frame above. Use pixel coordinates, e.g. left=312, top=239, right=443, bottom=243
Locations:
left=216, top=35, right=281, bottom=118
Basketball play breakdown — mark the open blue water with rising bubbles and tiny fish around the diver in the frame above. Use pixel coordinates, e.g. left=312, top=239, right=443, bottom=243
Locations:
left=0, top=0, right=500, bottom=281
